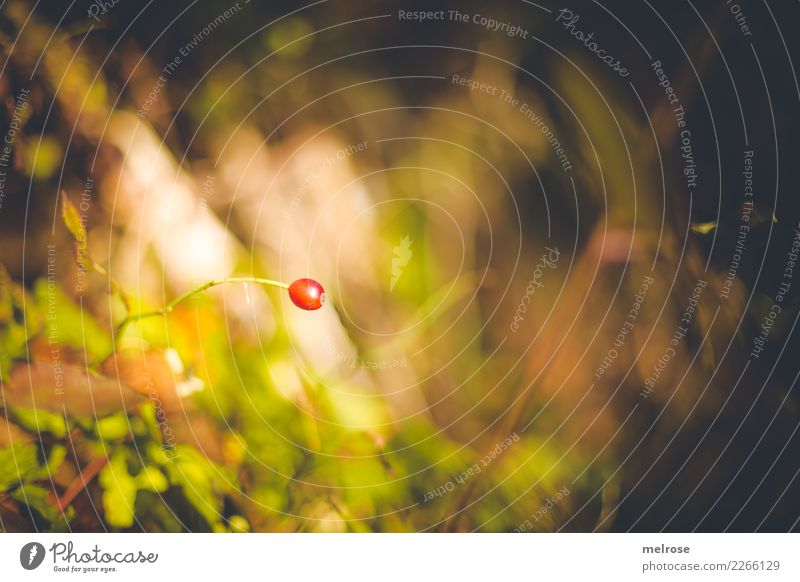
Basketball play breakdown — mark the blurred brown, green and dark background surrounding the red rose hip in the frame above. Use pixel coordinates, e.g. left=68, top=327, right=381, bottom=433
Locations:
left=0, top=0, right=800, bottom=532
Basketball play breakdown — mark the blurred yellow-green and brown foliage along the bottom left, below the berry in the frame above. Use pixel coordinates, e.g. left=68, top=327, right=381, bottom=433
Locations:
left=0, top=249, right=601, bottom=531
